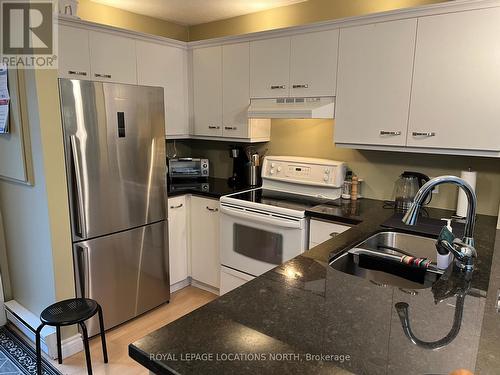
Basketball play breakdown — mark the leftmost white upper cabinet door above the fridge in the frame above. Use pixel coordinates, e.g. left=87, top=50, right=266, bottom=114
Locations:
left=58, top=25, right=90, bottom=79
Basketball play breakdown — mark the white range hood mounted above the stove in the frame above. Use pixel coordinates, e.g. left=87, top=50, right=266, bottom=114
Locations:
left=248, top=96, right=335, bottom=119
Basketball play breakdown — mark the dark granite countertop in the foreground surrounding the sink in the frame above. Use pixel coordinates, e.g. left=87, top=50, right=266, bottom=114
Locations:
left=129, top=199, right=500, bottom=375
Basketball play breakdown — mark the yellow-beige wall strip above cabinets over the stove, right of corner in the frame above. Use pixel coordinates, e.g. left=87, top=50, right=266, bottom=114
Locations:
left=189, top=0, right=444, bottom=41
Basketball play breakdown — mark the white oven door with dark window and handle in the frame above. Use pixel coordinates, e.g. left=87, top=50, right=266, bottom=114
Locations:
left=220, top=204, right=307, bottom=276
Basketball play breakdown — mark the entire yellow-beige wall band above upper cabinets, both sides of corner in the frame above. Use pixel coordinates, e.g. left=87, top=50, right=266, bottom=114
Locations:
left=73, top=0, right=446, bottom=41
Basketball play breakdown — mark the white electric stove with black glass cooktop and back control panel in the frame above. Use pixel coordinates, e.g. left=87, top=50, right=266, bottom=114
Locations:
left=220, top=156, right=345, bottom=295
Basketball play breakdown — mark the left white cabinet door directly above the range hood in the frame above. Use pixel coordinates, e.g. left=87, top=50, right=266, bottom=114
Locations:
left=250, top=37, right=290, bottom=98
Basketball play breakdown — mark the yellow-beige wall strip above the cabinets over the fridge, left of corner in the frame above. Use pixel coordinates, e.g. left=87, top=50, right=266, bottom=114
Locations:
left=78, top=0, right=189, bottom=41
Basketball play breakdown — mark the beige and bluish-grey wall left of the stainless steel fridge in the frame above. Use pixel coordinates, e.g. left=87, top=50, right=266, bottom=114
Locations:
left=0, top=70, right=76, bottom=337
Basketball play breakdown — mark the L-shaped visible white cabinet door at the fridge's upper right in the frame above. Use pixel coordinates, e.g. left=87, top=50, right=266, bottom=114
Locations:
left=136, top=41, right=189, bottom=136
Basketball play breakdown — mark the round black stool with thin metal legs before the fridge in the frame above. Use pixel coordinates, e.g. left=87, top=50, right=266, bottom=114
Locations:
left=36, top=298, right=108, bottom=375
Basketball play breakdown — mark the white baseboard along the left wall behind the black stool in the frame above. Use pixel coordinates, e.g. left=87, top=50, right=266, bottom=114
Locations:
left=5, top=300, right=83, bottom=359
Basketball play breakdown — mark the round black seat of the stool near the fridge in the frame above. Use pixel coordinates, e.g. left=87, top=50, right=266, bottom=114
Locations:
left=40, top=298, right=98, bottom=326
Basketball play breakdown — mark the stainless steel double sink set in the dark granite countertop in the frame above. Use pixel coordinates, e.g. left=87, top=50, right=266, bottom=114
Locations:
left=330, top=231, right=443, bottom=289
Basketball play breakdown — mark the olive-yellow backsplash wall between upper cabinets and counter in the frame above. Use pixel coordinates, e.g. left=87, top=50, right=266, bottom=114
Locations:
left=167, top=120, right=500, bottom=216
